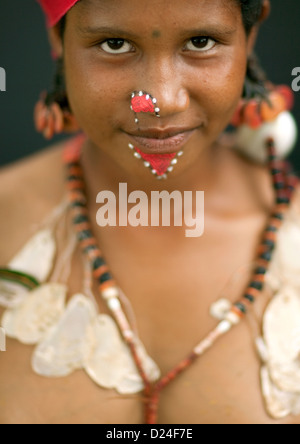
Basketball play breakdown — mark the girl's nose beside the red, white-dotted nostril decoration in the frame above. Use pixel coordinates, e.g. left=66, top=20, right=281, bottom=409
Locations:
left=140, top=59, right=190, bottom=118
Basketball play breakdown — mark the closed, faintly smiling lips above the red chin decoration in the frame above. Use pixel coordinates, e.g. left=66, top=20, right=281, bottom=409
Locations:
left=127, top=128, right=198, bottom=154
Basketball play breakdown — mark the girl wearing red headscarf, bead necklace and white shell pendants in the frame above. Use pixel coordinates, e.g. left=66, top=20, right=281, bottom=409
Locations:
left=0, top=0, right=300, bottom=424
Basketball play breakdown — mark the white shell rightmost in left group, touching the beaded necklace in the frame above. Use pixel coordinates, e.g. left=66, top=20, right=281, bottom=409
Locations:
left=84, top=315, right=160, bottom=394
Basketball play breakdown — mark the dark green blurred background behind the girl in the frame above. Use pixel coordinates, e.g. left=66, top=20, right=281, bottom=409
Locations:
left=0, top=0, right=300, bottom=172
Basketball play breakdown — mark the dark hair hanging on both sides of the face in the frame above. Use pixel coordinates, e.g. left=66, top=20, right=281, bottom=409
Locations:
left=45, top=0, right=267, bottom=110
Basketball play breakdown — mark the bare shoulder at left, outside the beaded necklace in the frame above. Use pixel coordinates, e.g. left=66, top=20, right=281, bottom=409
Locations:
left=0, top=143, right=64, bottom=265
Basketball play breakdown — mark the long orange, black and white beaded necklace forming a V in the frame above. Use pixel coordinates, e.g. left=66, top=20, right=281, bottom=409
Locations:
left=64, top=136, right=299, bottom=424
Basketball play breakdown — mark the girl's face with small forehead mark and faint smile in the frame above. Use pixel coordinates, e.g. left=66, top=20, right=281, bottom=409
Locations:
left=64, top=0, right=250, bottom=180
